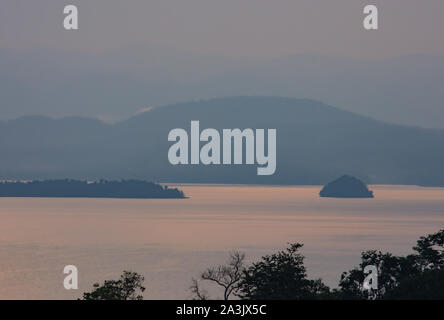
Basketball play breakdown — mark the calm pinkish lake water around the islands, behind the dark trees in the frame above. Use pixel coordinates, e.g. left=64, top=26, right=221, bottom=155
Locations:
left=0, top=185, right=444, bottom=299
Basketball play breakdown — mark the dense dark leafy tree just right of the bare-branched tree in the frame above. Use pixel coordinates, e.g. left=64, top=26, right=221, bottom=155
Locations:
left=237, top=243, right=330, bottom=300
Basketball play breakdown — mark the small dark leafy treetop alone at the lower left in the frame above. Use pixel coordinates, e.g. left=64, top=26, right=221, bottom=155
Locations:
left=83, top=271, right=145, bottom=300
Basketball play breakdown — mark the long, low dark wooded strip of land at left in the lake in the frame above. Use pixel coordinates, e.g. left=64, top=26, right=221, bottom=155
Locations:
left=0, top=179, right=185, bottom=199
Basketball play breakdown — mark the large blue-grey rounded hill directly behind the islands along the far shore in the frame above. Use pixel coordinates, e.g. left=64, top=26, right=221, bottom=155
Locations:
left=0, top=97, right=444, bottom=186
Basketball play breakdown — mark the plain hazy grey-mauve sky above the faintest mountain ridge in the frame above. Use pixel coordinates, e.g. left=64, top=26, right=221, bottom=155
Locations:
left=0, top=0, right=444, bottom=57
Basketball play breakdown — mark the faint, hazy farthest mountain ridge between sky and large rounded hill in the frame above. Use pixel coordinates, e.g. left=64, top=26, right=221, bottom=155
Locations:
left=0, top=46, right=444, bottom=128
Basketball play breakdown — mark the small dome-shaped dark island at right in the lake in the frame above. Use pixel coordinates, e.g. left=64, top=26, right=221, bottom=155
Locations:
left=319, top=175, right=374, bottom=198
